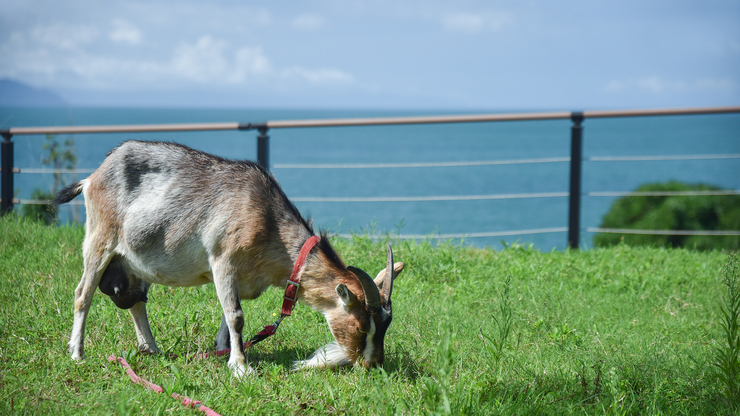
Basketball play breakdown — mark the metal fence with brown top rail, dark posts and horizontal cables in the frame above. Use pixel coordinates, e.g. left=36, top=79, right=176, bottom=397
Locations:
left=0, top=107, right=740, bottom=248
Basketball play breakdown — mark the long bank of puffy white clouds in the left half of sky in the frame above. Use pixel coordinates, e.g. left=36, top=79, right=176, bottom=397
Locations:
left=0, top=28, right=355, bottom=90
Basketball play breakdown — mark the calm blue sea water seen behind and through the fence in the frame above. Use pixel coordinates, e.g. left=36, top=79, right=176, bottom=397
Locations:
left=0, top=107, right=740, bottom=251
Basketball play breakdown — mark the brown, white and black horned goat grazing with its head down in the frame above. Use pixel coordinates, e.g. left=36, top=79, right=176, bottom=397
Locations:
left=55, top=141, right=404, bottom=377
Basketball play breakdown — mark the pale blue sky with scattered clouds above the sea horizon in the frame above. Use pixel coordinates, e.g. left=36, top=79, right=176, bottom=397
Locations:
left=0, top=0, right=740, bottom=110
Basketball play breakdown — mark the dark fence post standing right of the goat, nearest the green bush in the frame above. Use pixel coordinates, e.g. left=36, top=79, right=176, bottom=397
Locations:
left=568, top=111, right=583, bottom=249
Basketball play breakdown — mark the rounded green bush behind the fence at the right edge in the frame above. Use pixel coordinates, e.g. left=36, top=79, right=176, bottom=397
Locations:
left=594, top=182, right=740, bottom=250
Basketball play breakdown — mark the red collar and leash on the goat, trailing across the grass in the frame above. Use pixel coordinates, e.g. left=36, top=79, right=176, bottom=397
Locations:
left=108, top=235, right=319, bottom=416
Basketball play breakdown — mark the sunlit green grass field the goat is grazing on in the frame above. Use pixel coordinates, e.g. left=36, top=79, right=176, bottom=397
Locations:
left=0, top=218, right=732, bottom=415
